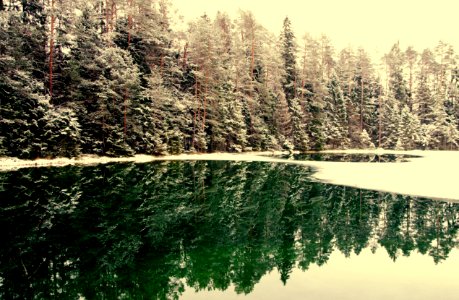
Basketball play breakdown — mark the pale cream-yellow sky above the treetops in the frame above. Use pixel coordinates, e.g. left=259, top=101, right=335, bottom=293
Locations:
left=172, top=0, right=459, bottom=55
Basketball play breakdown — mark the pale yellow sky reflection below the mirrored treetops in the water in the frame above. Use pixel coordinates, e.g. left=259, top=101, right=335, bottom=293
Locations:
left=181, top=248, right=459, bottom=300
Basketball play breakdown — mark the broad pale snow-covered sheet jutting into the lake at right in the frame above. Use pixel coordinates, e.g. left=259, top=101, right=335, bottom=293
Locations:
left=312, top=151, right=459, bottom=201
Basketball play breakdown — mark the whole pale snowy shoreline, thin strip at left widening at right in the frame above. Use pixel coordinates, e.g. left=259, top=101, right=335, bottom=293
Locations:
left=0, top=149, right=459, bottom=201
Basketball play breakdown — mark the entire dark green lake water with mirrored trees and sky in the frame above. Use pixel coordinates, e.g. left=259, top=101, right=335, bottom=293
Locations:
left=0, top=161, right=459, bottom=299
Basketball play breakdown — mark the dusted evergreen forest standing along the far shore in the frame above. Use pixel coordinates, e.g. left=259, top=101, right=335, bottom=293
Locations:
left=0, top=0, right=459, bottom=158
